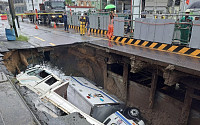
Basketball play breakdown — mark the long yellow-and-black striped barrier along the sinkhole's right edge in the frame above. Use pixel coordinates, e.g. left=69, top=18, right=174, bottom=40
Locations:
left=111, top=36, right=200, bottom=58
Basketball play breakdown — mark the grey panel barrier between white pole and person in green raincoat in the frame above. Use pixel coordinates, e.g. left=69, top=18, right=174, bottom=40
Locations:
left=134, top=18, right=175, bottom=44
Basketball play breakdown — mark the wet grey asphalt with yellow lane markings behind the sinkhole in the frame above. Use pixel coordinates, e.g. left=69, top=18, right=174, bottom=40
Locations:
left=21, top=20, right=103, bottom=48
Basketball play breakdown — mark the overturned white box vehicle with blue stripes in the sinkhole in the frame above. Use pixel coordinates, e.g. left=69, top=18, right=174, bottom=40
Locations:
left=67, top=76, right=144, bottom=125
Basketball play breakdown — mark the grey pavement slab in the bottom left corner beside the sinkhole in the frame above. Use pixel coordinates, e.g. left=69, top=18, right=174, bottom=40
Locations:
left=0, top=72, right=35, bottom=125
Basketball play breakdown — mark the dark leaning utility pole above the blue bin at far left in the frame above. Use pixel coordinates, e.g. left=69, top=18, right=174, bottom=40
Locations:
left=8, top=0, right=18, bottom=37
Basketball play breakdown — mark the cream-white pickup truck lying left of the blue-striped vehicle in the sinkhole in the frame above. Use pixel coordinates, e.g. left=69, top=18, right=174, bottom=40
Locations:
left=16, top=65, right=103, bottom=125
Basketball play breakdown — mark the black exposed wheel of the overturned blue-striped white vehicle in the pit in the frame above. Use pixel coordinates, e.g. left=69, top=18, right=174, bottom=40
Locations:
left=124, top=107, right=140, bottom=119
